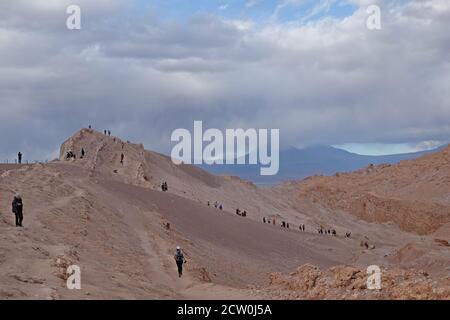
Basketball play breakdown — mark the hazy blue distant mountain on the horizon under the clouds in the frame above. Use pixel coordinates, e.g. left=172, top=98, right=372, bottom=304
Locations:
left=200, top=146, right=445, bottom=185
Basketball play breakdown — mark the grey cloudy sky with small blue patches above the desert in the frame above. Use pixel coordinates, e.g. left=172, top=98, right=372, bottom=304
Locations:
left=0, top=0, right=450, bottom=160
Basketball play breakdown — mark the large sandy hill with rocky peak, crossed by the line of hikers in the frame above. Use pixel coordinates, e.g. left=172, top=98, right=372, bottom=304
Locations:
left=0, top=129, right=450, bottom=299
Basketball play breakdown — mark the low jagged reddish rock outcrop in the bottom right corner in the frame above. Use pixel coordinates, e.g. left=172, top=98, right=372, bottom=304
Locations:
left=267, top=264, right=450, bottom=300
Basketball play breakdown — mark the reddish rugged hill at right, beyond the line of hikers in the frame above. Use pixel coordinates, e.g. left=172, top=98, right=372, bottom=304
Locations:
left=290, top=147, right=450, bottom=235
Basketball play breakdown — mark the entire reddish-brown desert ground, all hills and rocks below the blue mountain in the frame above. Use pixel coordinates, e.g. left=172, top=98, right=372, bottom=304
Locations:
left=0, top=129, right=450, bottom=299
